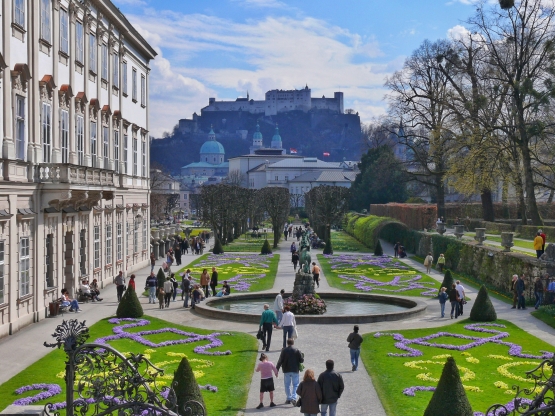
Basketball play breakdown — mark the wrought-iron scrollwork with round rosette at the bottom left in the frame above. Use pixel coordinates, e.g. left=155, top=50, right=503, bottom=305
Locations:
left=44, top=319, right=205, bottom=416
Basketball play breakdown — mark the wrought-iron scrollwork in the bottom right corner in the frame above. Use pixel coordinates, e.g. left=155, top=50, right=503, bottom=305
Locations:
left=485, top=355, right=555, bottom=416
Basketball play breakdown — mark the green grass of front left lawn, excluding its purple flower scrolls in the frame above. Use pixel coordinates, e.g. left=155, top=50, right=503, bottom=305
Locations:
left=0, top=316, right=257, bottom=416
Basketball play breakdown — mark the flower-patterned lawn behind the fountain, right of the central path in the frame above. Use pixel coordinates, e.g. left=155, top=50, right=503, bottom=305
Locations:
left=318, top=253, right=440, bottom=296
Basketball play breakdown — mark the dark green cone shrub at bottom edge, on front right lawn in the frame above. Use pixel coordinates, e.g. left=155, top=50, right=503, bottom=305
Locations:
left=424, top=357, right=474, bottom=416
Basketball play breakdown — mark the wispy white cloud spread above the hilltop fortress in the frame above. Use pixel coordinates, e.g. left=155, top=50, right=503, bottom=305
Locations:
left=129, top=11, right=401, bottom=136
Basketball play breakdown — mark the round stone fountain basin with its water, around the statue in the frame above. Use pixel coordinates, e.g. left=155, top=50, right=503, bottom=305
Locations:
left=195, top=293, right=426, bottom=324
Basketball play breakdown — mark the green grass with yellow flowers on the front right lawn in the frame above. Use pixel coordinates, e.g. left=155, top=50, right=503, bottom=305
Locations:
left=361, top=320, right=553, bottom=415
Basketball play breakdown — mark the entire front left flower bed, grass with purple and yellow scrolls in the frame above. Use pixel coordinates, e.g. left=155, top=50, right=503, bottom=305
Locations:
left=0, top=317, right=257, bottom=416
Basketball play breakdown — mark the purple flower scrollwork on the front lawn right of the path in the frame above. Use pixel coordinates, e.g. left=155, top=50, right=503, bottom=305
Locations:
left=374, top=323, right=553, bottom=360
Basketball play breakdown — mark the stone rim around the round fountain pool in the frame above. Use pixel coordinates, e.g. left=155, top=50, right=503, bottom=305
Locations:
left=191, top=292, right=427, bottom=324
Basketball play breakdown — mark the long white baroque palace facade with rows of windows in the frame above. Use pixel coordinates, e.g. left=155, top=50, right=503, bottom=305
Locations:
left=0, top=0, right=156, bottom=336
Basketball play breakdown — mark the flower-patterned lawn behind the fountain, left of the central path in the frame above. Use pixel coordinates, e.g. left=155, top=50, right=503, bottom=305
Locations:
left=178, top=253, right=279, bottom=292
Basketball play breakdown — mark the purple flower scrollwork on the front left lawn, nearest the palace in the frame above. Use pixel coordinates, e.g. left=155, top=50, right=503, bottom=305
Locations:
left=94, top=318, right=231, bottom=355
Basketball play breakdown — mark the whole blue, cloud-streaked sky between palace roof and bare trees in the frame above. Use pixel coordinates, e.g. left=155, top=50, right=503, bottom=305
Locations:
left=113, top=0, right=482, bottom=137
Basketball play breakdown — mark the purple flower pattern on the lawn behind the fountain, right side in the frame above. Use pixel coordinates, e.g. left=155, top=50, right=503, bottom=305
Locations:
left=324, top=254, right=437, bottom=296
